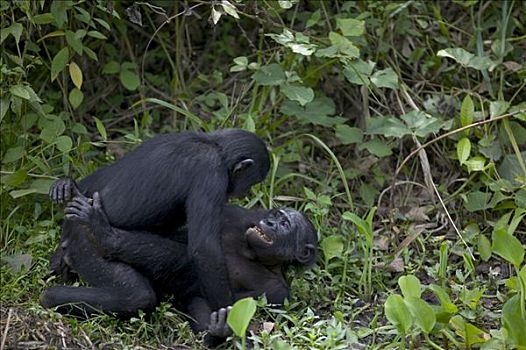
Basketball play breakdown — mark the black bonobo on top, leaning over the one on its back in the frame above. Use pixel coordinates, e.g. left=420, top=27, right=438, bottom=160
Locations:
left=49, top=129, right=270, bottom=308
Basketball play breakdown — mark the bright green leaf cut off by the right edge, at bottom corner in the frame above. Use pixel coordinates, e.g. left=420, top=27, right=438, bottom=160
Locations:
left=502, top=294, right=526, bottom=349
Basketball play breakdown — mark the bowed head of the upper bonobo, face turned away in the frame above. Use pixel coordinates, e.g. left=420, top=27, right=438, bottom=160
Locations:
left=212, top=129, right=270, bottom=197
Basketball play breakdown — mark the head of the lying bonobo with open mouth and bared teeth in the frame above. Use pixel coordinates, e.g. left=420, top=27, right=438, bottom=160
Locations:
left=245, top=208, right=318, bottom=266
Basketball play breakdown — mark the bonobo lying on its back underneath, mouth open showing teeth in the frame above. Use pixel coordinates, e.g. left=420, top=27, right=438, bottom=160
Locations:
left=41, top=192, right=317, bottom=343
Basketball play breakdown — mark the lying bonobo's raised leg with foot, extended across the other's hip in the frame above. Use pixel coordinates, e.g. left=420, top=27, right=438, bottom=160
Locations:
left=64, top=192, right=189, bottom=279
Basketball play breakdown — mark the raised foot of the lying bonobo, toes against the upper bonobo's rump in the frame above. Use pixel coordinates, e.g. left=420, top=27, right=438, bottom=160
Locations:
left=64, top=192, right=118, bottom=257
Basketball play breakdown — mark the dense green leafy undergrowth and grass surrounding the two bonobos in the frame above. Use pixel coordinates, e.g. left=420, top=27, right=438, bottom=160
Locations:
left=0, top=0, right=526, bottom=349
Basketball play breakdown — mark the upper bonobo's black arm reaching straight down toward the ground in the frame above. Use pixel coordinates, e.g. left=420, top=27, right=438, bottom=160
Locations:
left=186, top=179, right=232, bottom=309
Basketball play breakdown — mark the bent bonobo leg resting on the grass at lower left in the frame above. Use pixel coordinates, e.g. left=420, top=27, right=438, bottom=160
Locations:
left=40, top=222, right=157, bottom=317
